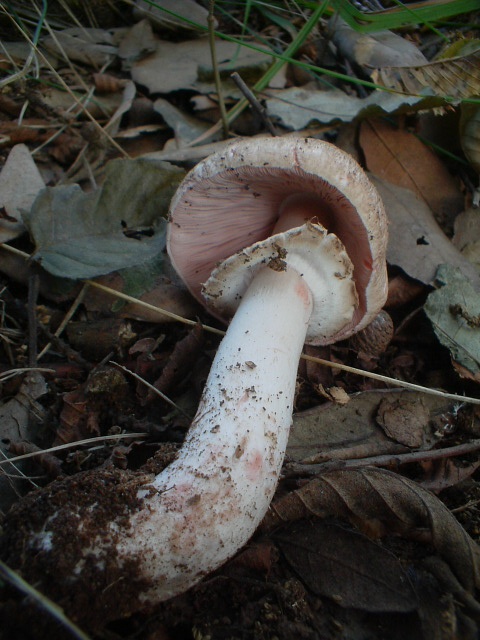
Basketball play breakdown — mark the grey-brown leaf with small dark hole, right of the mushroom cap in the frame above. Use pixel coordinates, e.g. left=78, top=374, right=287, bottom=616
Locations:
left=370, top=175, right=480, bottom=291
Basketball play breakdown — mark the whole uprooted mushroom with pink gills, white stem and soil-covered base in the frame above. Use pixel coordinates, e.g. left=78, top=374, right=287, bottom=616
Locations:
left=2, top=138, right=387, bottom=626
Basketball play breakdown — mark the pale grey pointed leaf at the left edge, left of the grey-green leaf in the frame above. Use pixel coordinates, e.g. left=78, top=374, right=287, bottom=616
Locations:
left=0, top=144, right=45, bottom=242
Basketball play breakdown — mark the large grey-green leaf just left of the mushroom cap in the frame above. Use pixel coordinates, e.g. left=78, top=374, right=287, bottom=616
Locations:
left=24, top=159, right=184, bottom=279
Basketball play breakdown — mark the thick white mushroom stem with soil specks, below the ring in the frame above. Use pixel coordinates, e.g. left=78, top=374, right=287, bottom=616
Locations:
left=118, top=267, right=312, bottom=602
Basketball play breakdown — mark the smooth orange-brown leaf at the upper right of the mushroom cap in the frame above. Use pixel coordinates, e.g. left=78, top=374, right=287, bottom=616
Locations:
left=360, top=120, right=464, bottom=228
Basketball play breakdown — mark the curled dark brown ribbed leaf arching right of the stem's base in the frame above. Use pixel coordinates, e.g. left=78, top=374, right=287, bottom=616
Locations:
left=263, top=468, right=480, bottom=593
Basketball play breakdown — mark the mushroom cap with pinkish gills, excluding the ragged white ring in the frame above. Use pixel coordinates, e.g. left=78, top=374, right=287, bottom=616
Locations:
left=167, top=137, right=388, bottom=344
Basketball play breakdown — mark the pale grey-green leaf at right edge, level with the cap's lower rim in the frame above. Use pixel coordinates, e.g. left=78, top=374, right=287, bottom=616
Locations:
left=424, top=265, right=480, bottom=382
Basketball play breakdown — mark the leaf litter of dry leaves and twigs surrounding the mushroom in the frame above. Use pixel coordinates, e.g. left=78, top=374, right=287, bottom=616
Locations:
left=0, top=2, right=480, bottom=639
